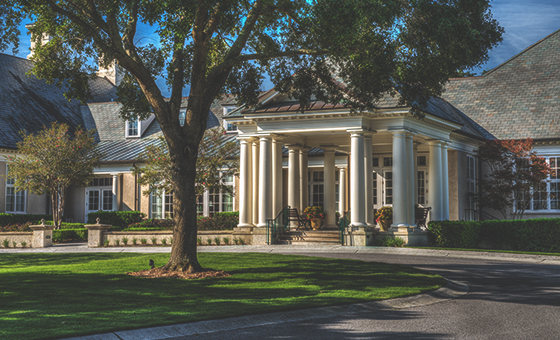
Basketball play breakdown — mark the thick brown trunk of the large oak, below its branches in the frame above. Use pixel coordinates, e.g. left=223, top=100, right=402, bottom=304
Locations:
left=162, top=143, right=202, bottom=273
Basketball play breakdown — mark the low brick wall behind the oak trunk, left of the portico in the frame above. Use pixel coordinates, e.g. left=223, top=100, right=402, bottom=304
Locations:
left=102, top=230, right=234, bottom=246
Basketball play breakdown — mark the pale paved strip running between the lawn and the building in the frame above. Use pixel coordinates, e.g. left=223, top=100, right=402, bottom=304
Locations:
left=0, top=243, right=560, bottom=265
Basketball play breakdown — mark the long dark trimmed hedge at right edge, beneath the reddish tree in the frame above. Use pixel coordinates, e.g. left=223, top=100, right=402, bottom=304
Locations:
left=428, top=218, right=560, bottom=252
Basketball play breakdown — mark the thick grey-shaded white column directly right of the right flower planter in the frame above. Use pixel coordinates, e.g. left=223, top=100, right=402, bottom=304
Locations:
left=391, top=130, right=408, bottom=227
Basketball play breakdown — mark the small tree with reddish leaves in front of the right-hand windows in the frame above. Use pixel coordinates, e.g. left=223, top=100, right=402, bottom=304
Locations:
left=479, top=138, right=550, bottom=219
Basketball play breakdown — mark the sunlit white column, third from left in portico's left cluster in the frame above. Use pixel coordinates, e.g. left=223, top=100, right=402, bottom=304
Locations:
left=257, top=136, right=272, bottom=228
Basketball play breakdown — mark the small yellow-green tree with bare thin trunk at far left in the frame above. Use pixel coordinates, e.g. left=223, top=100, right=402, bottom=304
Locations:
left=5, top=122, right=101, bottom=228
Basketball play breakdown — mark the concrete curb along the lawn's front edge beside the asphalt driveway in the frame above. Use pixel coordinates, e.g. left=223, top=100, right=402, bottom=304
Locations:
left=62, top=280, right=469, bottom=340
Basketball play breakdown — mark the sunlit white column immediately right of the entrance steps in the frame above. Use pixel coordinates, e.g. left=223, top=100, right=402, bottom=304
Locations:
left=349, top=129, right=367, bottom=227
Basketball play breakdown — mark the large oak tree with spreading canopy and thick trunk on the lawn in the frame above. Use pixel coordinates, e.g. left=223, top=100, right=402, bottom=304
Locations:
left=0, top=0, right=503, bottom=271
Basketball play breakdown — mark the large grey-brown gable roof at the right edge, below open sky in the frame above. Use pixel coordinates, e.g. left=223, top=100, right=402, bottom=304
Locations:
left=443, top=30, right=560, bottom=139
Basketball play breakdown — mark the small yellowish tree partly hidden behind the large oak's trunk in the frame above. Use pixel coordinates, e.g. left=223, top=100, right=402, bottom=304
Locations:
left=136, top=128, right=239, bottom=205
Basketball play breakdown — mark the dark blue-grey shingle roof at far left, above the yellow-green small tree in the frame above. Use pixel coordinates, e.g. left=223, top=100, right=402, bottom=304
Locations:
left=0, top=53, right=114, bottom=148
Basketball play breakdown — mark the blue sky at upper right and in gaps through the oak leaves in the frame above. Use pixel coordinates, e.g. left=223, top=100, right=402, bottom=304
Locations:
left=5, top=0, right=560, bottom=95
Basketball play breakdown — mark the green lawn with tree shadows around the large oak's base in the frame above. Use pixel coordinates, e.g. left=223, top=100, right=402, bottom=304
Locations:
left=0, top=253, right=445, bottom=340
